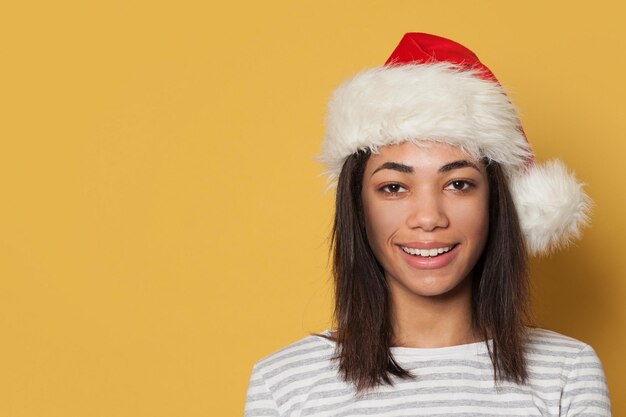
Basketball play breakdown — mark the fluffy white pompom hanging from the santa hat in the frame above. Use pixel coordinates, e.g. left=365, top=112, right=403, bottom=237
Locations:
left=511, top=160, right=592, bottom=255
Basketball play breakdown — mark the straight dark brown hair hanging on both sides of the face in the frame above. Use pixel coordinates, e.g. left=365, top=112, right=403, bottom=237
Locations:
left=331, top=151, right=531, bottom=392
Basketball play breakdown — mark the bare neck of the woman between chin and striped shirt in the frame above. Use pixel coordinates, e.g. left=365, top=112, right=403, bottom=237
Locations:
left=388, top=272, right=482, bottom=348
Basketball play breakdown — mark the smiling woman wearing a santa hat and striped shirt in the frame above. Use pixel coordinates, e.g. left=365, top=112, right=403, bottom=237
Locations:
left=246, top=33, right=610, bottom=416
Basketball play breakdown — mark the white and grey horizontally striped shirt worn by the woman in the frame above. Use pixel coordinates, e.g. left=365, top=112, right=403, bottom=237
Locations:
left=245, top=328, right=611, bottom=417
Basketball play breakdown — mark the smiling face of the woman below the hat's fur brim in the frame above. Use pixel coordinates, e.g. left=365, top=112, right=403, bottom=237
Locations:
left=362, top=142, right=489, bottom=297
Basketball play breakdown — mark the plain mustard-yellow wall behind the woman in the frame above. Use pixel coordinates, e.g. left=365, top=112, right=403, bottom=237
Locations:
left=0, top=0, right=626, bottom=417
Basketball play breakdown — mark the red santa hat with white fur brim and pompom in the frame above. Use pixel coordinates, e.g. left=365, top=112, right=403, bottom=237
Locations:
left=320, top=33, right=591, bottom=254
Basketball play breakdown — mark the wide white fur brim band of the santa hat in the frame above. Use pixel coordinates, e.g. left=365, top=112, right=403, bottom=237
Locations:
left=319, top=62, right=532, bottom=181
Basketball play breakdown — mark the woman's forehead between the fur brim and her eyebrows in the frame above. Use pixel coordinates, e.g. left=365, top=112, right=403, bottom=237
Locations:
left=366, top=141, right=482, bottom=171
